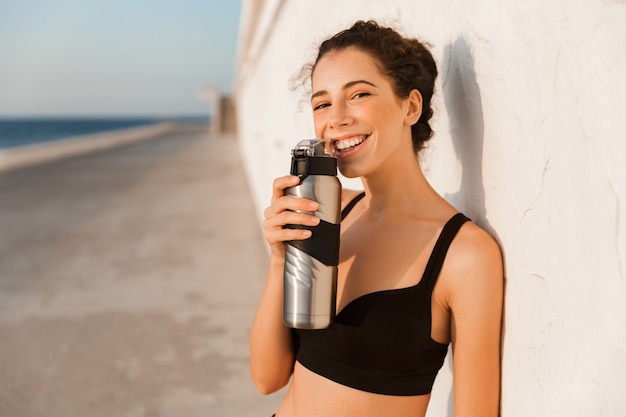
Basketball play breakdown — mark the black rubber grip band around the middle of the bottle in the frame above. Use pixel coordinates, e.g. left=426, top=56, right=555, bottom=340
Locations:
left=285, top=220, right=341, bottom=266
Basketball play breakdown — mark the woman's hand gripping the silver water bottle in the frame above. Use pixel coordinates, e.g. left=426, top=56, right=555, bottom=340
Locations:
left=263, top=175, right=320, bottom=258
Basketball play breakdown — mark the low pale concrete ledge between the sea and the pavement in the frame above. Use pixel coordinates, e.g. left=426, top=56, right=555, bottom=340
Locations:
left=0, top=122, right=176, bottom=172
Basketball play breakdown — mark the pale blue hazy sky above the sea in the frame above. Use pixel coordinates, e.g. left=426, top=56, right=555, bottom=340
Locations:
left=0, top=0, right=241, bottom=118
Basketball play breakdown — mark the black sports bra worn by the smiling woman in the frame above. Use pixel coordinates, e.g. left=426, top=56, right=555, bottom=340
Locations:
left=295, top=195, right=469, bottom=396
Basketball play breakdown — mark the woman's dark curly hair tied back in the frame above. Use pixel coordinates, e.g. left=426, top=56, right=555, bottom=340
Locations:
left=310, top=20, right=437, bottom=152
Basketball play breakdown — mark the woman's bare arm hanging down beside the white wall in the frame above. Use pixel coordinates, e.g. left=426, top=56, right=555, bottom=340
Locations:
left=448, top=223, right=504, bottom=417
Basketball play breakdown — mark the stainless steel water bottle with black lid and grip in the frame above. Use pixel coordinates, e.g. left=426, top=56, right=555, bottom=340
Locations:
left=283, top=139, right=341, bottom=329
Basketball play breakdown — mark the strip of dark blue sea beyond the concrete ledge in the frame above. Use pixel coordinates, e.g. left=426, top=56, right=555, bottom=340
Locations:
left=0, top=117, right=178, bottom=149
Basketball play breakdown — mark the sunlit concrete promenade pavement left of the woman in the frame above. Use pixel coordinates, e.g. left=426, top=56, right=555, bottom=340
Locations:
left=0, top=124, right=282, bottom=417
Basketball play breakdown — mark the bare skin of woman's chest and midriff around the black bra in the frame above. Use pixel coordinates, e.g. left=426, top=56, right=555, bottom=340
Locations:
left=277, top=191, right=454, bottom=417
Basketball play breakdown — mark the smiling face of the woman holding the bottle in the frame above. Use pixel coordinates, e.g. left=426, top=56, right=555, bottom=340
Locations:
left=311, top=47, right=413, bottom=177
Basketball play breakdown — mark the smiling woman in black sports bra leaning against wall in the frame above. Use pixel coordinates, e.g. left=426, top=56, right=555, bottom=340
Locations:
left=250, top=21, right=503, bottom=417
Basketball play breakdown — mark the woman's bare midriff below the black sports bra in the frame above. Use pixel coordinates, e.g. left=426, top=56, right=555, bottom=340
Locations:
left=276, top=362, right=430, bottom=417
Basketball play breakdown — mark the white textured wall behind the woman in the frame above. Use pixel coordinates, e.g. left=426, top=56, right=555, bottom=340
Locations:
left=236, top=0, right=626, bottom=417
